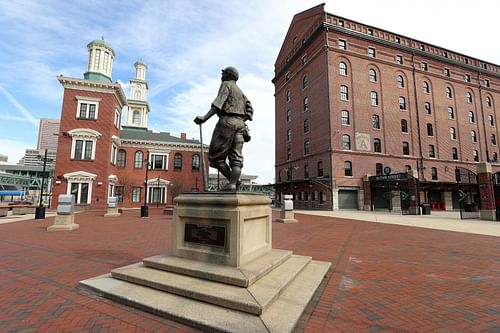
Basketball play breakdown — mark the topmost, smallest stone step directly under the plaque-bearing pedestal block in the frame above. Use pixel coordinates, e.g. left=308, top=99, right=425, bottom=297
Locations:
left=143, top=249, right=292, bottom=287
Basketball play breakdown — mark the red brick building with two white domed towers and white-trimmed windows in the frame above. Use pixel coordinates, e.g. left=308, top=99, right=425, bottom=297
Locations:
left=52, top=40, right=208, bottom=209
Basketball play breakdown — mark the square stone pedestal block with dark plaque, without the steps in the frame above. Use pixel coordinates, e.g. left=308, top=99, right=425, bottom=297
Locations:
left=172, top=192, right=272, bottom=267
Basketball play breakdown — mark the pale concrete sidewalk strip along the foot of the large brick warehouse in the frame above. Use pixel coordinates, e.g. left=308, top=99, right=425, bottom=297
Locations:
left=295, top=210, right=500, bottom=237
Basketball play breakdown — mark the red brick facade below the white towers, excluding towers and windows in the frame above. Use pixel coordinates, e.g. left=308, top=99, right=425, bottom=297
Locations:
left=52, top=77, right=208, bottom=209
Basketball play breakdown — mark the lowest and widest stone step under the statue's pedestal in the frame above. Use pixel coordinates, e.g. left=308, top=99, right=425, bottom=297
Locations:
left=79, top=261, right=330, bottom=333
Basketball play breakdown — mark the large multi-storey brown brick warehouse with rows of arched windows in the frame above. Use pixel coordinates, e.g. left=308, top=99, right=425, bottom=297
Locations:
left=273, top=5, right=500, bottom=210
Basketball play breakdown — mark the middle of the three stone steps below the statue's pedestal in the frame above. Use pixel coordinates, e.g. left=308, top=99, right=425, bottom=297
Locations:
left=111, top=255, right=311, bottom=315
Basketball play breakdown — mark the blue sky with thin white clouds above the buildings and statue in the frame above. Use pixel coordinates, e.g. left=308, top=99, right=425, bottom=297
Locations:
left=0, top=0, right=500, bottom=183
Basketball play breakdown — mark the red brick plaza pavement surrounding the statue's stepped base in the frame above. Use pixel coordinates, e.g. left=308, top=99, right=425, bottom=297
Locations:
left=0, top=208, right=500, bottom=332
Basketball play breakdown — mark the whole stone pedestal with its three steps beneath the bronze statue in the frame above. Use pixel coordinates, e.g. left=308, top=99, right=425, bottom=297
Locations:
left=79, top=193, right=331, bottom=333
